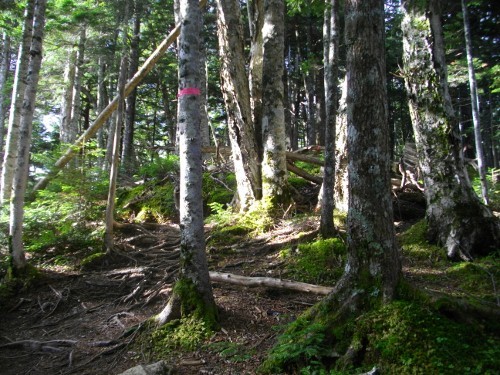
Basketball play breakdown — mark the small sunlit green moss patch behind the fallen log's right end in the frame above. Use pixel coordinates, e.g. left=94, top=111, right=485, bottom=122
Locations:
left=280, top=238, right=346, bottom=285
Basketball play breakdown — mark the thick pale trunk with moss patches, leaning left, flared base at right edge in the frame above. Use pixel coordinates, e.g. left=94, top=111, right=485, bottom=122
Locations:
left=402, top=0, right=500, bottom=260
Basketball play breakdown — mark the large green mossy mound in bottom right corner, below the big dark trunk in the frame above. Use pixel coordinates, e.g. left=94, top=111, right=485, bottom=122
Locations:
left=261, top=300, right=500, bottom=374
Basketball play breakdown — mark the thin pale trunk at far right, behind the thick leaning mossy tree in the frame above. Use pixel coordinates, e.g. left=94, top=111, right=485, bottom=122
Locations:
left=462, top=0, right=489, bottom=205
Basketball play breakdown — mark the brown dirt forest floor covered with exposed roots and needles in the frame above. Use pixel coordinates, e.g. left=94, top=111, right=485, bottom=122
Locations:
left=0, top=216, right=498, bottom=375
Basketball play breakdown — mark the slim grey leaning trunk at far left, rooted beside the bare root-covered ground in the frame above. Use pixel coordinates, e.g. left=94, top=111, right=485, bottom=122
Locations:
left=9, top=0, right=47, bottom=270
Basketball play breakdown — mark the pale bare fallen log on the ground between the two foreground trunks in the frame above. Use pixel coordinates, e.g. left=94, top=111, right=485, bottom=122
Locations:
left=209, top=271, right=333, bottom=295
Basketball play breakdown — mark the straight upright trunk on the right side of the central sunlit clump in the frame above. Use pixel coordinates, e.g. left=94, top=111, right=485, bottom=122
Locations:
left=261, top=0, right=290, bottom=209
